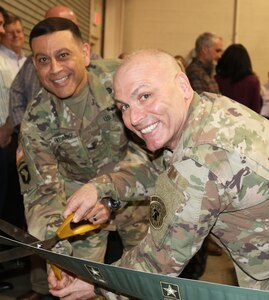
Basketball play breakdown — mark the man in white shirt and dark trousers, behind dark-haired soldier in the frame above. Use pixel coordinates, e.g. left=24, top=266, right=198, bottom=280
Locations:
left=0, top=15, right=26, bottom=227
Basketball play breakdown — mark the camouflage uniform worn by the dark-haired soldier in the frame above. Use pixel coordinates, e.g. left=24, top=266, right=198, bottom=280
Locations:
left=17, top=60, right=162, bottom=261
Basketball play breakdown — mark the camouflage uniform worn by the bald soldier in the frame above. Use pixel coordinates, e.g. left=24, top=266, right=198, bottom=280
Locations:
left=117, top=93, right=269, bottom=290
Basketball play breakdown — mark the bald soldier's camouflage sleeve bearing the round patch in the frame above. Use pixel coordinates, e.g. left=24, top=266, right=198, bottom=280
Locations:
left=112, top=159, right=220, bottom=275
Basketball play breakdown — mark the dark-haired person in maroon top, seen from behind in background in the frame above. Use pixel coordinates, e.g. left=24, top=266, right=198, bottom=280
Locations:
left=215, top=44, right=262, bottom=113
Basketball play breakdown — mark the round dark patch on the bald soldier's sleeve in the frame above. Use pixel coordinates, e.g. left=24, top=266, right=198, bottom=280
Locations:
left=149, top=196, right=166, bottom=229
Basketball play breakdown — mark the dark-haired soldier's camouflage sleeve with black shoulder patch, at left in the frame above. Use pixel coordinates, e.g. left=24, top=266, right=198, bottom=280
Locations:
left=17, top=113, right=66, bottom=240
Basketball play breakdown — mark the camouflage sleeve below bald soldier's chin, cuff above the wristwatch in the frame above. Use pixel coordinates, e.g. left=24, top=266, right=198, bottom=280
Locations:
left=90, top=141, right=164, bottom=201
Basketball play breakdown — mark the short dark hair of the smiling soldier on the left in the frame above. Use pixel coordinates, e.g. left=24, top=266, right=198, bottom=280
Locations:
left=29, top=17, right=83, bottom=48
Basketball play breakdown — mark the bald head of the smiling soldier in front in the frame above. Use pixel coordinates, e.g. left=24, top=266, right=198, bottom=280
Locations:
left=113, top=49, right=193, bottom=151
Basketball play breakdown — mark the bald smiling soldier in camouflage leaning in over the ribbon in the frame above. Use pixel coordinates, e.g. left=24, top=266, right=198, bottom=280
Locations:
left=49, top=50, right=269, bottom=299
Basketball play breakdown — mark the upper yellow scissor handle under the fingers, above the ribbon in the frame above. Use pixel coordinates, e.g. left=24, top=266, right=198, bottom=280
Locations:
left=56, top=213, right=100, bottom=239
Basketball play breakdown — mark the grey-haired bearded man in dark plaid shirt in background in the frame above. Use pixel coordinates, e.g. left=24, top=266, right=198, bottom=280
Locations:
left=186, top=32, right=223, bottom=94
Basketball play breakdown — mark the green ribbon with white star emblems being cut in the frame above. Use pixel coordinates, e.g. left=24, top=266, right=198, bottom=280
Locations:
left=0, top=236, right=269, bottom=300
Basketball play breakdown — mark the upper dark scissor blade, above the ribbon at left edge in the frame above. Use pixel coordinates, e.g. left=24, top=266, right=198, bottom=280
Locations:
left=0, top=219, right=38, bottom=243
